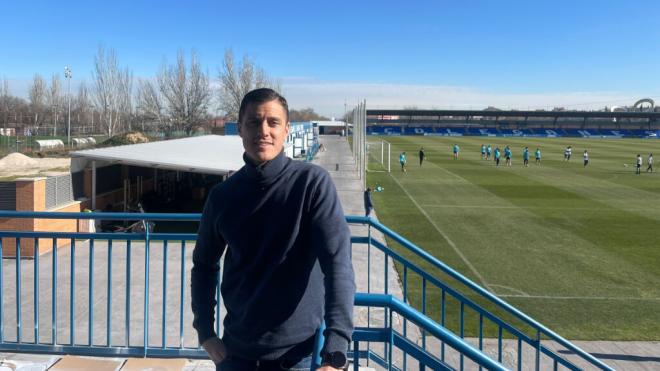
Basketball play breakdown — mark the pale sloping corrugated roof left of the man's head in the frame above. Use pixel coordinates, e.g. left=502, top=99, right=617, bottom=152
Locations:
left=71, top=135, right=244, bottom=174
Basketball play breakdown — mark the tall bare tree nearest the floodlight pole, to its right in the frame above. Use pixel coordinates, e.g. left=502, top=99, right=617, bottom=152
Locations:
left=92, top=46, right=133, bottom=137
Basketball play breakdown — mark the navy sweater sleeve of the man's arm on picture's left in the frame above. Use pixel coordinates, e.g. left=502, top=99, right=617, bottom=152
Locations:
left=190, top=193, right=225, bottom=344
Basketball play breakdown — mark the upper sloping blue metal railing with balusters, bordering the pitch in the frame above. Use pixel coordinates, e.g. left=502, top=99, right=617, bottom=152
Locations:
left=347, top=216, right=612, bottom=370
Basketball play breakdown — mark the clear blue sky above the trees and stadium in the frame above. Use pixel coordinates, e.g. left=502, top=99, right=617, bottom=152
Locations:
left=0, top=0, right=660, bottom=116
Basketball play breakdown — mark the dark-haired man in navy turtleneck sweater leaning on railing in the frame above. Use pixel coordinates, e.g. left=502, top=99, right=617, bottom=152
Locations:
left=191, top=89, right=355, bottom=371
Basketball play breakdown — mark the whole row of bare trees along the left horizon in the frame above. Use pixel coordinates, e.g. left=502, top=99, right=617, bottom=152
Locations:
left=0, top=47, right=294, bottom=136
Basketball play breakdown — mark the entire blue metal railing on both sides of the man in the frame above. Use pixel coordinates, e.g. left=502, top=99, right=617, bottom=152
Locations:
left=0, top=212, right=610, bottom=370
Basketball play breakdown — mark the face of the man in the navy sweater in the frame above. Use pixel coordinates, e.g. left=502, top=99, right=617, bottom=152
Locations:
left=238, top=100, right=289, bottom=164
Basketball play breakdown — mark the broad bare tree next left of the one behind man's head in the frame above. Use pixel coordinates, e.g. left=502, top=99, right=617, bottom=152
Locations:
left=157, top=51, right=211, bottom=134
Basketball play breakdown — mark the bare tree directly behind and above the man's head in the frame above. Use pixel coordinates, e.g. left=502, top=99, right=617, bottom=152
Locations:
left=219, top=49, right=281, bottom=120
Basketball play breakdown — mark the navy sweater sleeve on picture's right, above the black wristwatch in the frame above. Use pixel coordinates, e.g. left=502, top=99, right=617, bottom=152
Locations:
left=310, top=172, right=355, bottom=353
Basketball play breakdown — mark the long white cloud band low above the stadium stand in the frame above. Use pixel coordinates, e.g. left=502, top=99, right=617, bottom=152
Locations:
left=282, top=78, right=643, bottom=117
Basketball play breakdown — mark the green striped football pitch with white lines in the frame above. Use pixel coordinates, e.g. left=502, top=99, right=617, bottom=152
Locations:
left=367, top=136, right=660, bottom=340
